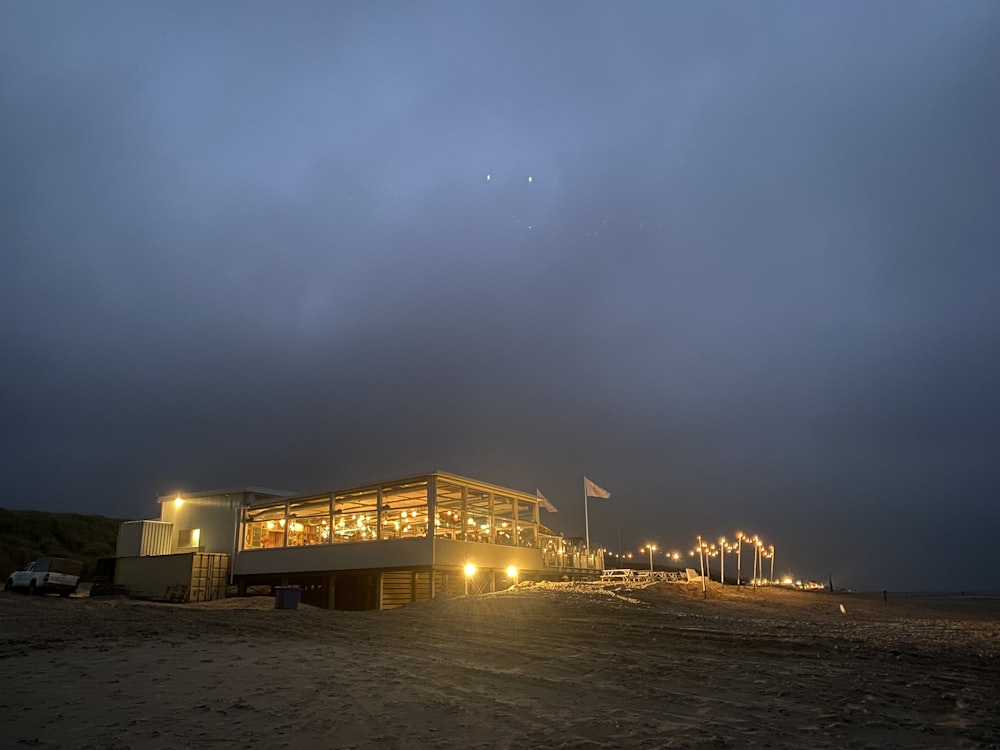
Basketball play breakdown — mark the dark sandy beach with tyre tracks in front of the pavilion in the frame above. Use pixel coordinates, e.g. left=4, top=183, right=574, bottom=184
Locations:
left=0, top=583, right=1000, bottom=749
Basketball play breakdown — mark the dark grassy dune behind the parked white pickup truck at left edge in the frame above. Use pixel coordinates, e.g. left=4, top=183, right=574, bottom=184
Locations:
left=0, top=508, right=121, bottom=580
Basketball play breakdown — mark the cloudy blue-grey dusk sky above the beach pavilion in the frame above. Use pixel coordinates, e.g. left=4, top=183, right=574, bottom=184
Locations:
left=0, top=1, right=1000, bottom=590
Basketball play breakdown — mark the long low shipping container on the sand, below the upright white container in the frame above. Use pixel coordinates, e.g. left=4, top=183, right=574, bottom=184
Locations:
left=115, top=552, right=229, bottom=602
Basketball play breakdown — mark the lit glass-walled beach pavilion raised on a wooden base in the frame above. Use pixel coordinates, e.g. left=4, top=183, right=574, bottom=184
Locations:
left=139, top=471, right=604, bottom=610
